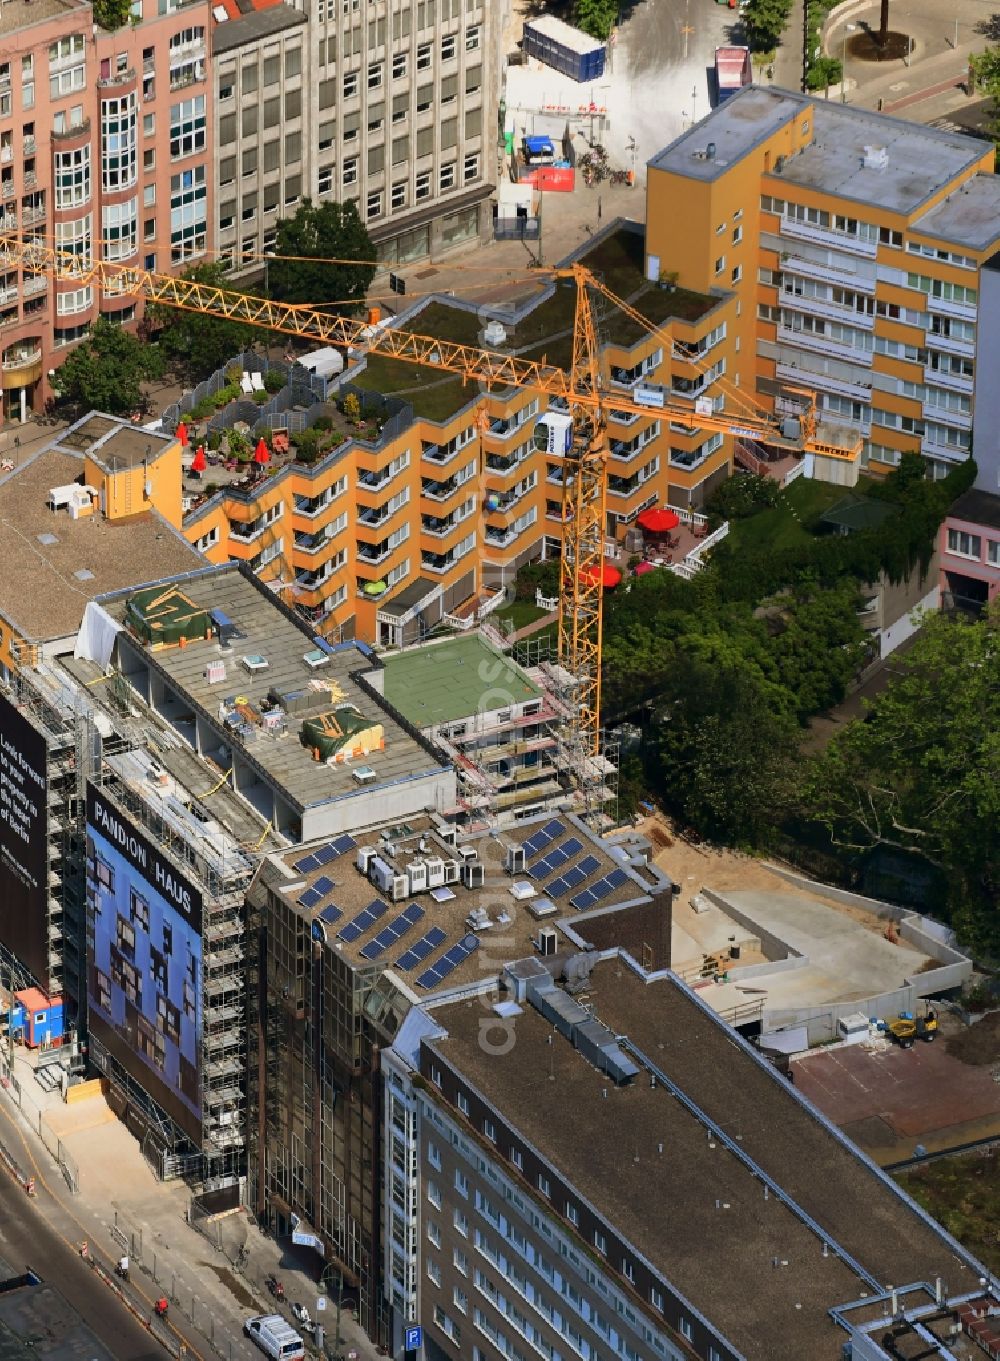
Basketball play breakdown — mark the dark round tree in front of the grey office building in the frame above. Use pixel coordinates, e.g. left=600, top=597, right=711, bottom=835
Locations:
left=268, top=199, right=376, bottom=316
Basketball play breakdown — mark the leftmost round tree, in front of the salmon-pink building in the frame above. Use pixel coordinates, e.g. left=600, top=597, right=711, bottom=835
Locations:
left=53, top=317, right=163, bottom=415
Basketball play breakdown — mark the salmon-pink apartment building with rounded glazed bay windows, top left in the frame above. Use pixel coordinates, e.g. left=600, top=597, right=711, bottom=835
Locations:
left=0, top=0, right=214, bottom=421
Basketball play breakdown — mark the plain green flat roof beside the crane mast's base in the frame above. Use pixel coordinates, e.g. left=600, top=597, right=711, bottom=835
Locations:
left=382, top=633, right=541, bottom=728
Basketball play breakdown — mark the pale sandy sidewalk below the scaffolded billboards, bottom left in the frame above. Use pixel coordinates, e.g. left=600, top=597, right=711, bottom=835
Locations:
left=0, top=1055, right=378, bottom=1361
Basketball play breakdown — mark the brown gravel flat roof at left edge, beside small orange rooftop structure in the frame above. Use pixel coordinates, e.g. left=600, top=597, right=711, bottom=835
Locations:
left=0, top=446, right=204, bottom=641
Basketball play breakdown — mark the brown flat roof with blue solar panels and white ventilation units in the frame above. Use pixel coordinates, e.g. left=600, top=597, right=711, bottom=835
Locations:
left=269, top=813, right=665, bottom=1002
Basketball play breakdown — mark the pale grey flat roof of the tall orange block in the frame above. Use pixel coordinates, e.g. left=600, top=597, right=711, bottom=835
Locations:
left=649, top=86, right=1000, bottom=219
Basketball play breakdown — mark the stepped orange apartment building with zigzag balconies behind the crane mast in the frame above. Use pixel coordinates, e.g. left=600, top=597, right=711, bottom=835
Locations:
left=184, top=225, right=736, bottom=645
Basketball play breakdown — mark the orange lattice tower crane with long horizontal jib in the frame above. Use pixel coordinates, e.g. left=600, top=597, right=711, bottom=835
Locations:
left=0, top=234, right=860, bottom=758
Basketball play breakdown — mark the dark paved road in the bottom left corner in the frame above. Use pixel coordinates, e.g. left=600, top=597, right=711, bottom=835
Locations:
left=0, top=1173, right=166, bottom=1361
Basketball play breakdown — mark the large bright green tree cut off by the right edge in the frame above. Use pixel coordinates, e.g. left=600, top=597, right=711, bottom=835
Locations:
left=804, top=603, right=1000, bottom=949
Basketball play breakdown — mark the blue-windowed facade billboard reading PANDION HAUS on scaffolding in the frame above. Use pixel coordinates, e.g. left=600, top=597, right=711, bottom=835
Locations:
left=87, top=784, right=203, bottom=1145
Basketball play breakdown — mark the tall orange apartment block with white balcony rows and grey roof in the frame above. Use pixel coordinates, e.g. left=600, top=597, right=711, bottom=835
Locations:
left=646, top=86, right=1000, bottom=476
